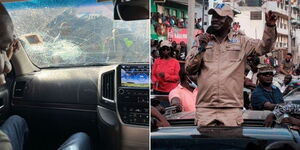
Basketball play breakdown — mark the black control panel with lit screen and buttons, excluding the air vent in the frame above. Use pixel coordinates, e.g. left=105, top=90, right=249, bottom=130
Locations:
left=117, top=64, right=150, bottom=126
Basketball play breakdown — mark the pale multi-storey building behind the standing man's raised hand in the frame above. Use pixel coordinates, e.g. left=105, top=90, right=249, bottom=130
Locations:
left=235, top=0, right=300, bottom=63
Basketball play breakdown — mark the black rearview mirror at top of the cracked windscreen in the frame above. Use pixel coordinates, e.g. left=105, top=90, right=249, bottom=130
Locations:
left=114, top=0, right=149, bottom=21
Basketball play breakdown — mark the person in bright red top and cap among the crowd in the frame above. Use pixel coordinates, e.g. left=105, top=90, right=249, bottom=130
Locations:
left=151, top=40, right=180, bottom=95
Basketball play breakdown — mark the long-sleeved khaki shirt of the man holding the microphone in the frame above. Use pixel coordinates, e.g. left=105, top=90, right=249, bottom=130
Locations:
left=185, top=26, right=277, bottom=108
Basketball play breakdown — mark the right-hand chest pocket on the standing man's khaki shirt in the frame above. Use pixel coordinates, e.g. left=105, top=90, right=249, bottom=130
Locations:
left=225, top=44, right=242, bottom=62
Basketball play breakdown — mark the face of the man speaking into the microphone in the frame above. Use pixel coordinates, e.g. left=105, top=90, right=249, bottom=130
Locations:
left=211, top=13, right=231, bottom=31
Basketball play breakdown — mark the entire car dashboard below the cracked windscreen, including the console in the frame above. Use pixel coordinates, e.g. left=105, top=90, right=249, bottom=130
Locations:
left=11, top=64, right=149, bottom=150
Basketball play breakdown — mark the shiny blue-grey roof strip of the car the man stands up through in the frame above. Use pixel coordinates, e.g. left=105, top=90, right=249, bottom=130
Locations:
left=155, top=126, right=299, bottom=141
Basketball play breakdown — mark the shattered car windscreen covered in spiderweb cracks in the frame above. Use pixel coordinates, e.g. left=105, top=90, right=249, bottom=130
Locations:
left=4, top=0, right=149, bottom=68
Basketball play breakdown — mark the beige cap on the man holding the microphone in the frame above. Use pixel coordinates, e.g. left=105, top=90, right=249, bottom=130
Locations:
left=208, top=3, right=234, bottom=20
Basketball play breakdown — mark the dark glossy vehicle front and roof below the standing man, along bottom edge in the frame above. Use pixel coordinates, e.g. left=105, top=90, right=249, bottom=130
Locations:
left=151, top=126, right=300, bottom=150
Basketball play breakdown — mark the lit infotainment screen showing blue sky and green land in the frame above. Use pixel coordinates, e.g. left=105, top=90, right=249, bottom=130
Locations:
left=120, top=65, right=149, bottom=88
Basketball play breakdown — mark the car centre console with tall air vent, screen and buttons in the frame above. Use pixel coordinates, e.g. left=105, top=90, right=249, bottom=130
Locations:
left=97, top=64, right=150, bottom=150
